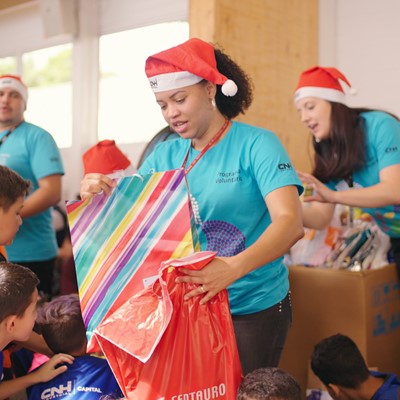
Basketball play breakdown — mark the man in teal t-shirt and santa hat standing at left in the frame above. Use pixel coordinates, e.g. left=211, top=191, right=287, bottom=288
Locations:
left=0, top=75, right=64, bottom=298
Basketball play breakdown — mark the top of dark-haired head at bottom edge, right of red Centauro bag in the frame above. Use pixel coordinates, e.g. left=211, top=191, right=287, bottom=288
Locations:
left=236, top=368, right=301, bottom=400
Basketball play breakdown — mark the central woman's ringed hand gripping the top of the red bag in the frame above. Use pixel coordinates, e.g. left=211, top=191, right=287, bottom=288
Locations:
left=176, top=257, right=239, bottom=304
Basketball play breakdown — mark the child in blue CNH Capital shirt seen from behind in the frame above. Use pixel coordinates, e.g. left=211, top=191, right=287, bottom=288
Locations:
left=28, top=294, right=123, bottom=400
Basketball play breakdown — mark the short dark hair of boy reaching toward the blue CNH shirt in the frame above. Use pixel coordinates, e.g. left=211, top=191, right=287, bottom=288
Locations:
left=0, top=262, right=39, bottom=322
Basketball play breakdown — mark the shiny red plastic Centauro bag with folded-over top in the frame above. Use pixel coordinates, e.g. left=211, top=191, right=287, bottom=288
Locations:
left=95, top=252, right=242, bottom=400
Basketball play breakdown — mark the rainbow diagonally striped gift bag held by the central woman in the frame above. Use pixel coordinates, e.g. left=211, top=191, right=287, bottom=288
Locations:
left=66, top=169, right=199, bottom=351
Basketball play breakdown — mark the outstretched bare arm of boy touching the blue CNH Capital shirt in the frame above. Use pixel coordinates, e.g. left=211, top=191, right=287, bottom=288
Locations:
left=0, top=354, right=74, bottom=400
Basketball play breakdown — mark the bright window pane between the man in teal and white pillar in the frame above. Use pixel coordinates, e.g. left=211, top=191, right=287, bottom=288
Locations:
left=22, top=44, right=72, bottom=148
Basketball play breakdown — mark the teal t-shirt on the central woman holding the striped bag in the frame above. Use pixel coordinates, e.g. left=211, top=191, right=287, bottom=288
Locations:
left=139, top=122, right=303, bottom=315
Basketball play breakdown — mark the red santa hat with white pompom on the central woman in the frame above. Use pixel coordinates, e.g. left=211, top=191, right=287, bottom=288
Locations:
left=145, top=38, right=238, bottom=96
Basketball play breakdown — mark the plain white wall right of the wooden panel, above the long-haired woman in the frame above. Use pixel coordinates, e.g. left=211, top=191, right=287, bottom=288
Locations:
left=319, top=0, right=400, bottom=116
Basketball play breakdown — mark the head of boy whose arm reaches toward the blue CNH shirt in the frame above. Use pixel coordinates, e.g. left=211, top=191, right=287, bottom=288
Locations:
left=0, top=262, right=39, bottom=347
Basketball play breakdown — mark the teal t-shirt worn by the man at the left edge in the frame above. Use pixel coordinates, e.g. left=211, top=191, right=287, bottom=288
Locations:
left=0, top=122, right=64, bottom=262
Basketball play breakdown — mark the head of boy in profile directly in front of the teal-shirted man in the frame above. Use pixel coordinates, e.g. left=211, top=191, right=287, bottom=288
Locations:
left=0, top=165, right=30, bottom=245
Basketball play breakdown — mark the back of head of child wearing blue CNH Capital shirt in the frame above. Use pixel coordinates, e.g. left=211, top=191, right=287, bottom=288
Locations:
left=37, top=294, right=87, bottom=356
